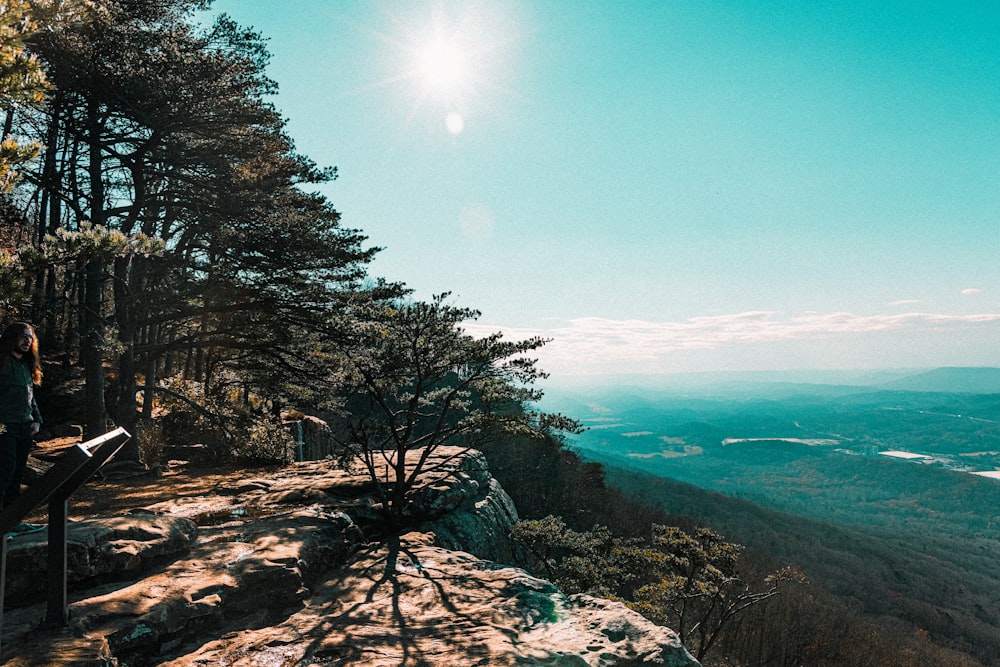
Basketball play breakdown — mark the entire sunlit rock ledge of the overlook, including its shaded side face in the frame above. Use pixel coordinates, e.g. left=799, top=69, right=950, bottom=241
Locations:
left=0, top=449, right=698, bottom=667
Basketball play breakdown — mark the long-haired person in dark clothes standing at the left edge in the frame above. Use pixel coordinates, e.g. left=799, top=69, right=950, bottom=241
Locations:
left=0, top=322, right=42, bottom=532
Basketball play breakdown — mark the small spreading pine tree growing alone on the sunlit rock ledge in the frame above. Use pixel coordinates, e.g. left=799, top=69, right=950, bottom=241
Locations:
left=338, top=294, right=572, bottom=523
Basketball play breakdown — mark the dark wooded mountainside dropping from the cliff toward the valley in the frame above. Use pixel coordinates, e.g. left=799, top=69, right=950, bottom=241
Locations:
left=478, top=430, right=984, bottom=667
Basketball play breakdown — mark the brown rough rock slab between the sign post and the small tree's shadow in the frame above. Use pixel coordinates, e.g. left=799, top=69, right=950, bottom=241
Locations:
left=4, top=508, right=361, bottom=667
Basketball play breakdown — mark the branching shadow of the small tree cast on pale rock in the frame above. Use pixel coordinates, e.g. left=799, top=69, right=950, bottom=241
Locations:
left=300, top=534, right=555, bottom=667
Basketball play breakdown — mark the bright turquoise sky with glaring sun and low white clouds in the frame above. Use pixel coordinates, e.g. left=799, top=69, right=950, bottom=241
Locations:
left=213, top=0, right=1000, bottom=375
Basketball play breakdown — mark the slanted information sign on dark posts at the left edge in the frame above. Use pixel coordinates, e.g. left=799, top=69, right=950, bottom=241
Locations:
left=0, top=428, right=132, bottom=656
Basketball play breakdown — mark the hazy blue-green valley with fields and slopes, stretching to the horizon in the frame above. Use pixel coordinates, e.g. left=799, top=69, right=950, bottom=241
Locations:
left=546, top=370, right=1000, bottom=664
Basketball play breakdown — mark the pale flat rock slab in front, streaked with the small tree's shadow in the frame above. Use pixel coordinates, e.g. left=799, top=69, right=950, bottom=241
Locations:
left=163, top=533, right=697, bottom=667
